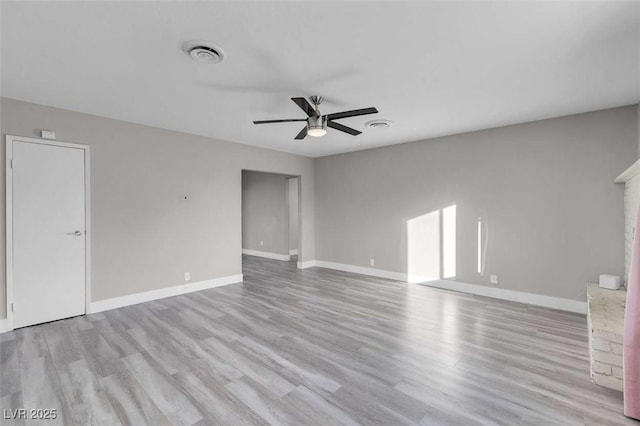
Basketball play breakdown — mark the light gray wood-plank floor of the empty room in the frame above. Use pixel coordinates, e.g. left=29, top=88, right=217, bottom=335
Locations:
left=0, top=257, right=639, bottom=425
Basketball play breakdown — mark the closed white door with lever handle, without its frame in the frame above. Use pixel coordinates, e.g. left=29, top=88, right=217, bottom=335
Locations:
left=11, top=141, right=86, bottom=328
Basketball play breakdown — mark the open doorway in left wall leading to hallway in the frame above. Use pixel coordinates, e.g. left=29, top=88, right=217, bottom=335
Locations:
left=242, top=170, right=301, bottom=268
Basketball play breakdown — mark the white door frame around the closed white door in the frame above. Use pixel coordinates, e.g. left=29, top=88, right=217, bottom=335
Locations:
left=5, top=135, right=91, bottom=331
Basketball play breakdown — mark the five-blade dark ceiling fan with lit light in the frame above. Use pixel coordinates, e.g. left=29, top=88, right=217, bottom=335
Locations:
left=253, top=96, right=378, bottom=139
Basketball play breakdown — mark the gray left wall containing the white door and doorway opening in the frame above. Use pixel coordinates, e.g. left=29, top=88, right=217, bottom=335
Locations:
left=0, top=99, right=315, bottom=318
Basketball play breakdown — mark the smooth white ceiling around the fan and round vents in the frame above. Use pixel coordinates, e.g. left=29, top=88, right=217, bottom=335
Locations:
left=1, top=1, right=640, bottom=157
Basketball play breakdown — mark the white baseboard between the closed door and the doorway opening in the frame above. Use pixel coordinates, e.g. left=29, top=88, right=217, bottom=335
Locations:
left=87, top=274, right=242, bottom=314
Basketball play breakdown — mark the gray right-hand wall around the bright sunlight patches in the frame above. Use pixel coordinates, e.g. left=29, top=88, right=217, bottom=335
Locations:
left=315, top=106, right=638, bottom=300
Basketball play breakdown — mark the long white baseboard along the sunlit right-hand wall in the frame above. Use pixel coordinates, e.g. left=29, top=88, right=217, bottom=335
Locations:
left=310, top=260, right=587, bottom=314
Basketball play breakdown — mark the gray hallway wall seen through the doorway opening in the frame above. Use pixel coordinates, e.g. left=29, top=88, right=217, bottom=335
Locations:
left=242, top=171, right=289, bottom=255
